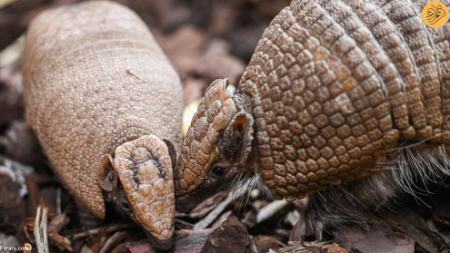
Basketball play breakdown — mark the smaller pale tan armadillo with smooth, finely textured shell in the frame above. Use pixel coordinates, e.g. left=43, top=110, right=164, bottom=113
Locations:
left=23, top=2, right=182, bottom=247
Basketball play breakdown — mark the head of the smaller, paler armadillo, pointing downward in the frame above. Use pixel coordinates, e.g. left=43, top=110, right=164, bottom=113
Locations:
left=100, top=135, right=175, bottom=249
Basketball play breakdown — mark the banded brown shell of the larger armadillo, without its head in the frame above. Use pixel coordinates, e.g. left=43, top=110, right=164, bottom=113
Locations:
left=238, top=0, right=450, bottom=197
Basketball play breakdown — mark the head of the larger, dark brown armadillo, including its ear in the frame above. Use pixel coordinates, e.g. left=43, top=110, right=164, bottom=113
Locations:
left=175, top=79, right=253, bottom=212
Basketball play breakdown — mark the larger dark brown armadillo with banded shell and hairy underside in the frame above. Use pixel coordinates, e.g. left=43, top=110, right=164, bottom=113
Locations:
left=175, top=0, right=450, bottom=218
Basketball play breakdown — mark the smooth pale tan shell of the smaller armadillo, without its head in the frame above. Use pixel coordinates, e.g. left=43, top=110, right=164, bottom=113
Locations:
left=24, top=2, right=182, bottom=219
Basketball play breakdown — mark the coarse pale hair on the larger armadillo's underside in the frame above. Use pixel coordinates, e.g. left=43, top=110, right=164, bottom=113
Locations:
left=307, top=142, right=450, bottom=228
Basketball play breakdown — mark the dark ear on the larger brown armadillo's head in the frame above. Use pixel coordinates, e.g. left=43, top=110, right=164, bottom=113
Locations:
left=219, top=111, right=253, bottom=165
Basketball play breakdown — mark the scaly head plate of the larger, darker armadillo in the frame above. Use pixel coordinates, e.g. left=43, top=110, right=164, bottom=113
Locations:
left=175, top=79, right=236, bottom=196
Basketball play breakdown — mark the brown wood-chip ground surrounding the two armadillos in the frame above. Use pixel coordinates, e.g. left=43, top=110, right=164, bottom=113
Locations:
left=0, top=0, right=450, bottom=253
